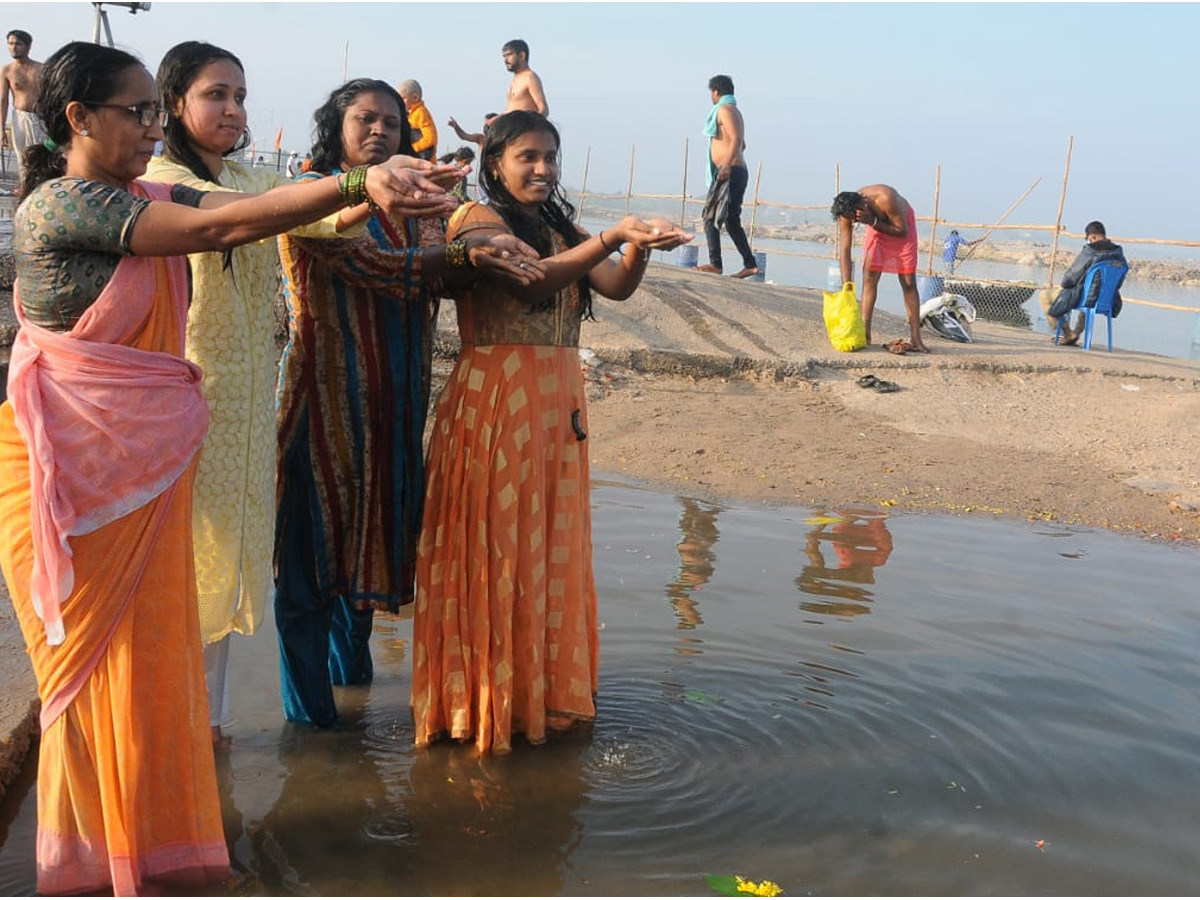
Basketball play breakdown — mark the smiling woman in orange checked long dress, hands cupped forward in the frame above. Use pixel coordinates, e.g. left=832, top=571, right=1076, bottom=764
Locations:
left=413, top=112, right=691, bottom=752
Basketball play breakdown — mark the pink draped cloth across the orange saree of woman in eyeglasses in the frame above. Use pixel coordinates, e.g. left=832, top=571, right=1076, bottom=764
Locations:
left=8, top=181, right=209, bottom=644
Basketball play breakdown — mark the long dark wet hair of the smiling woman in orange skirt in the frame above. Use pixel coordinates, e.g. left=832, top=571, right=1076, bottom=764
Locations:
left=479, top=109, right=595, bottom=320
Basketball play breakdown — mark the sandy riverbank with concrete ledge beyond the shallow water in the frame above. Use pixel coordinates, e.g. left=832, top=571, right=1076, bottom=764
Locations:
left=443, top=265, right=1200, bottom=544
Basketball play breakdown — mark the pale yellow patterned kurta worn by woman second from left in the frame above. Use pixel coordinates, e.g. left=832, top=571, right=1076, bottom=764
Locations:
left=145, top=157, right=348, bottom=643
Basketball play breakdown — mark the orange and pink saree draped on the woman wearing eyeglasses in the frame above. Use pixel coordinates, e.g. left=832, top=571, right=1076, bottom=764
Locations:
left=0, top=180, right=229, bottom=895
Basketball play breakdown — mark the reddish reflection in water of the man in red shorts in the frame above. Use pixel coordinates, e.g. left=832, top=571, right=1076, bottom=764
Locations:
left=796, top=509, right=892, bottom=616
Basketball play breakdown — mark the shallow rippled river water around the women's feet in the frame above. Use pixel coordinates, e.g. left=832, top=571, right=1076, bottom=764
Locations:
left=0, top=482, right=1200, bottom=895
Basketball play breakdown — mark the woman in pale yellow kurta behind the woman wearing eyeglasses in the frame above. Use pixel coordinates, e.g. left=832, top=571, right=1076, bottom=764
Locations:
left=146, top=41, right=361, bottom=746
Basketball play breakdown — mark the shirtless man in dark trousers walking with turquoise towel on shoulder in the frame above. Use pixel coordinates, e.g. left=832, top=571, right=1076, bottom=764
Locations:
left=696, top=76, right=758, bottom=278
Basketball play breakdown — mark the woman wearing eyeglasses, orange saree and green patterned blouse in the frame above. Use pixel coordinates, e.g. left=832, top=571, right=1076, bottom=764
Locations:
left=0, top=43, right=456, bottom=895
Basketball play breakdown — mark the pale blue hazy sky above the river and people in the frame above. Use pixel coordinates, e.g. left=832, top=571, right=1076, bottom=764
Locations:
left=0, top=0, right=1200, bottom=240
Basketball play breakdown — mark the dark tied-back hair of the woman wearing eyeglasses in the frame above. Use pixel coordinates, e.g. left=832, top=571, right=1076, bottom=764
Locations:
left=18, top=41, right=144, bottom=200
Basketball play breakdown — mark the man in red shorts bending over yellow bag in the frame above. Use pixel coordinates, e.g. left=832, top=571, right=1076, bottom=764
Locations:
left=830, top=185, right=929, bottom=353
